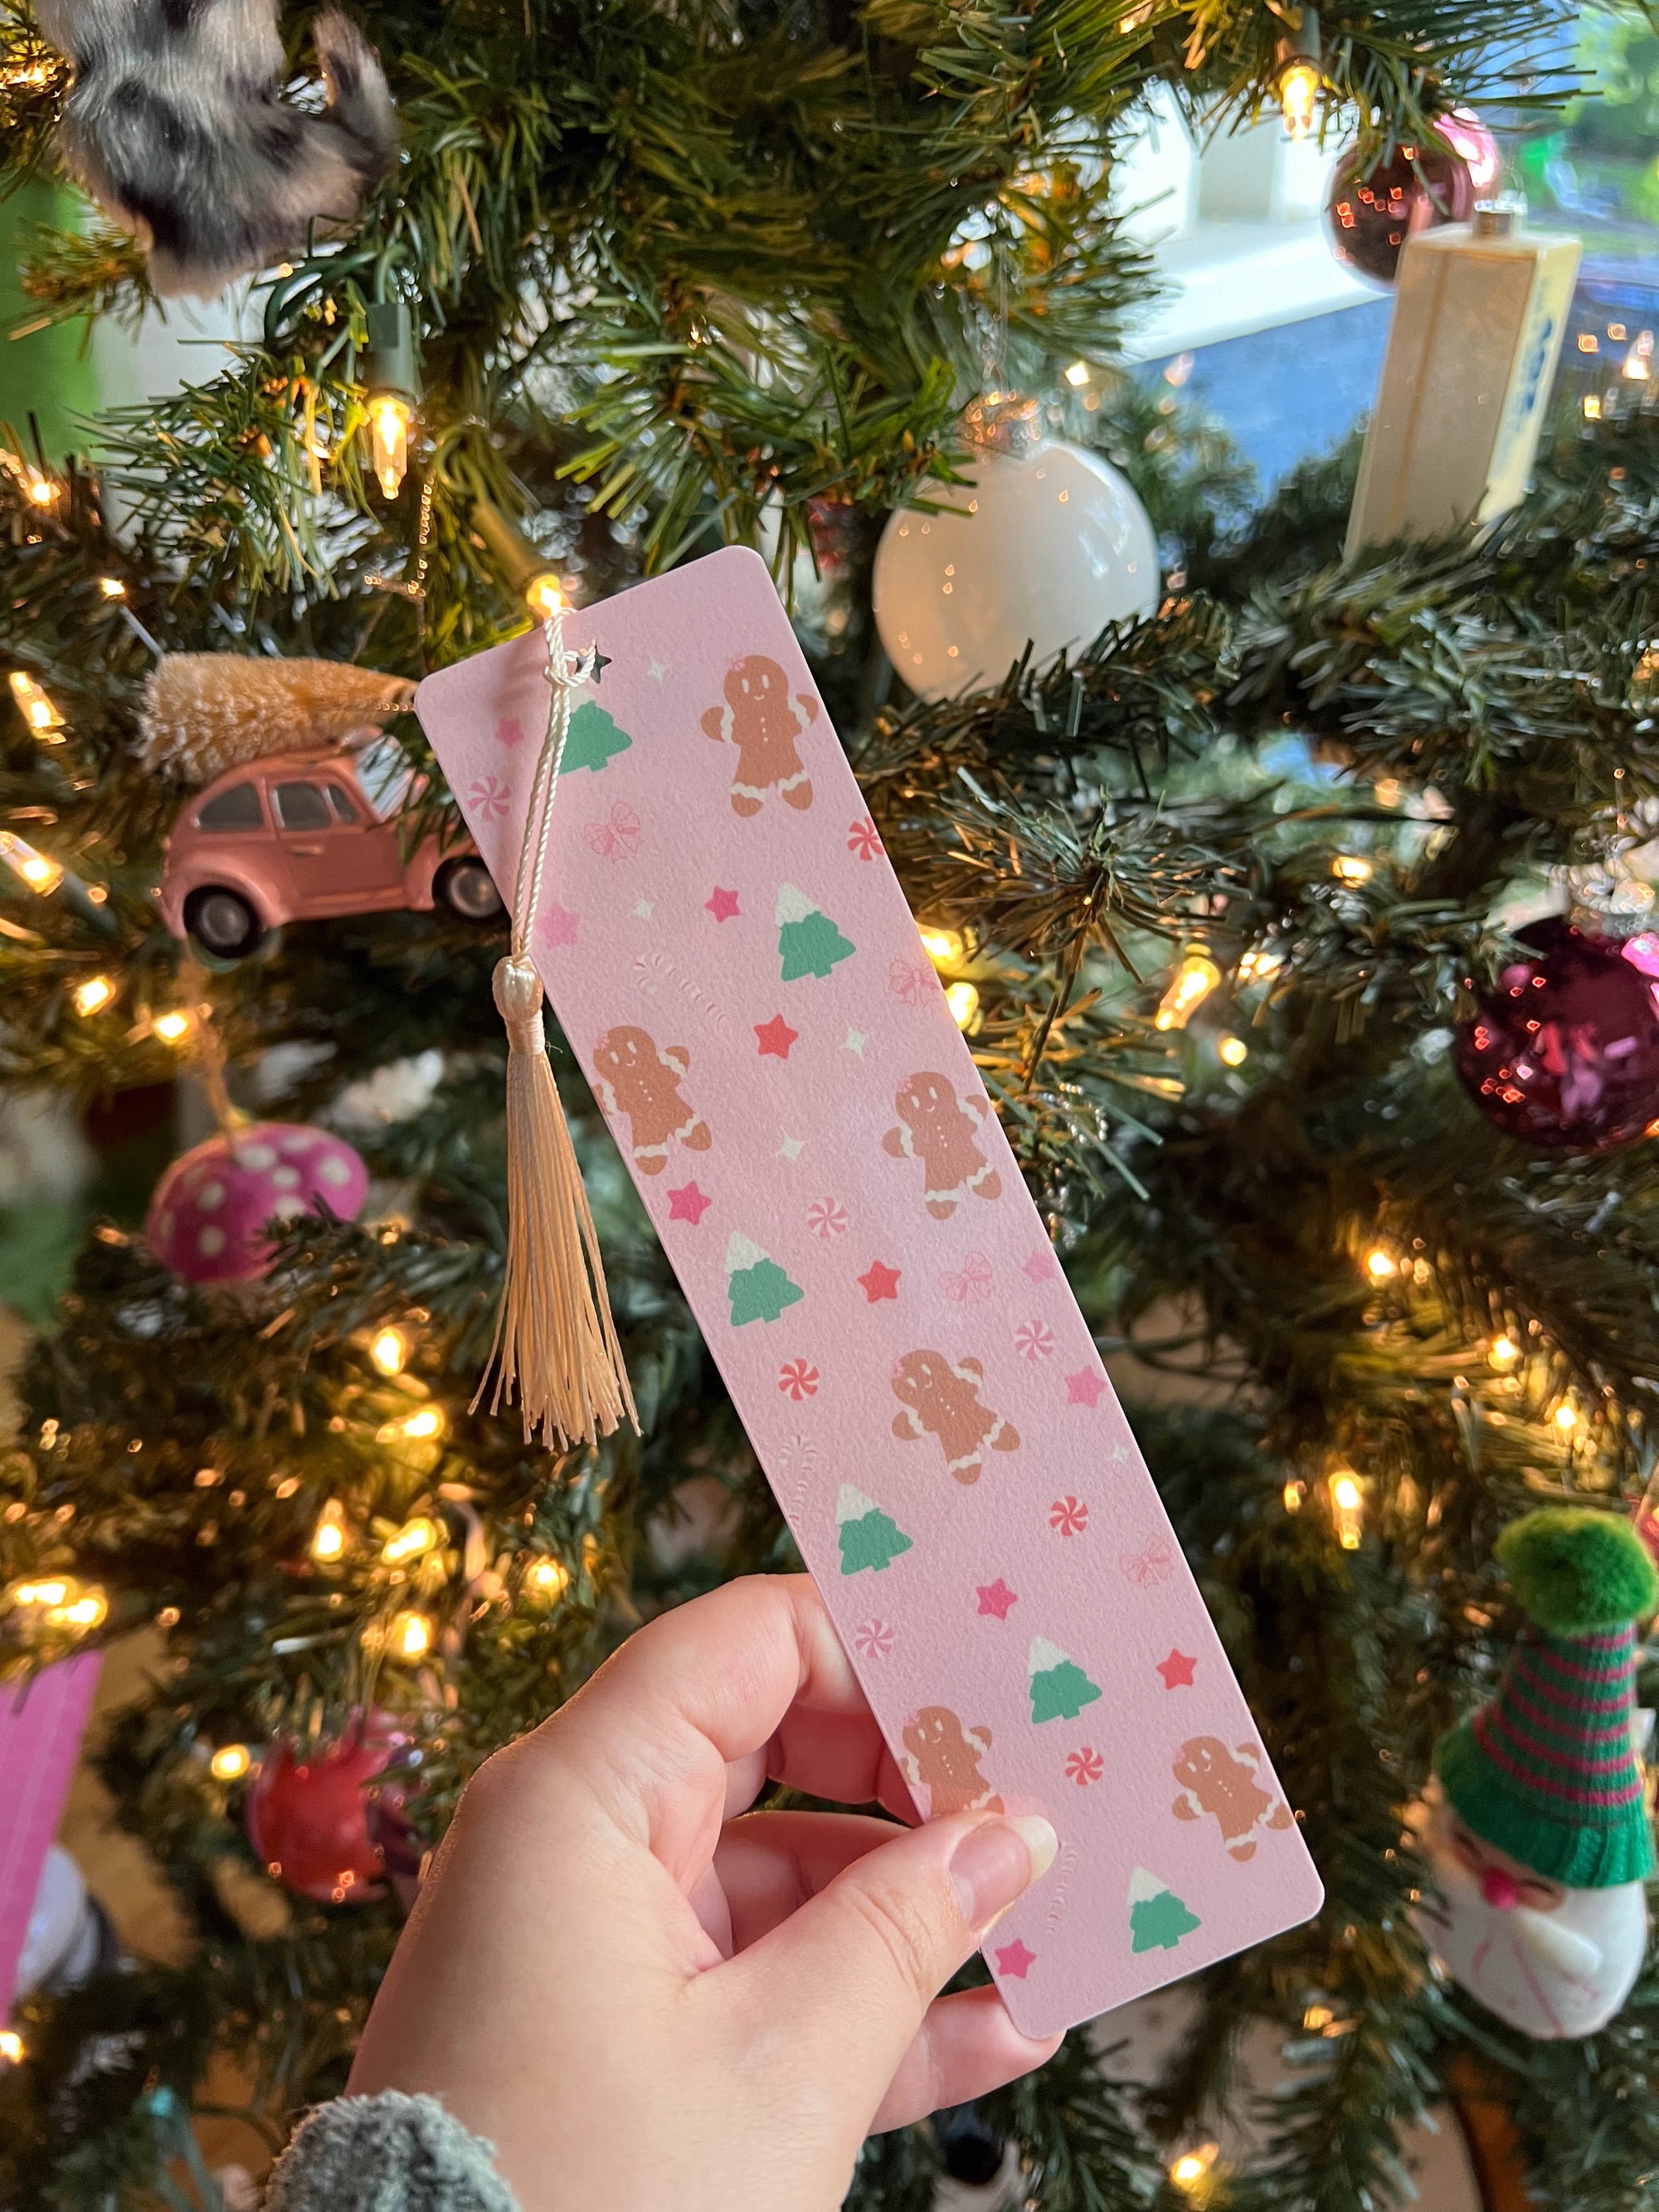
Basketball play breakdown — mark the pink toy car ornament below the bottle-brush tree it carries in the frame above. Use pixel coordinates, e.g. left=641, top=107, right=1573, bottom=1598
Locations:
left=162, top=739, right=507, bottom=960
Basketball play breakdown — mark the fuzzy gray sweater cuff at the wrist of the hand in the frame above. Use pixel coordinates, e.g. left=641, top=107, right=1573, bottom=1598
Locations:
left=265, top=2088, right=518, bottom=2212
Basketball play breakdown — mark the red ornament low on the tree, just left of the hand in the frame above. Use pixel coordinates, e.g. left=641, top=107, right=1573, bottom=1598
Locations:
left=248, top=1714, right=407, bottom=1904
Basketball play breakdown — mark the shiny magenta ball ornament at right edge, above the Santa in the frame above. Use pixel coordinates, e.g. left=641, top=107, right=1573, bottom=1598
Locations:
left=1456, top=918, right=1659, bottom=1153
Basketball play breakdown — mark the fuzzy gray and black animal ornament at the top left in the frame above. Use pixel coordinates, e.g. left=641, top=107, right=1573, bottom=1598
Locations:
left=37, top=0, right=398, bottom=299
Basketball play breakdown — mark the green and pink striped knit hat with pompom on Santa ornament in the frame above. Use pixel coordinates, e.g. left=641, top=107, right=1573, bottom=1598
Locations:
left=1433, top=1506, right=1659, bottom=1889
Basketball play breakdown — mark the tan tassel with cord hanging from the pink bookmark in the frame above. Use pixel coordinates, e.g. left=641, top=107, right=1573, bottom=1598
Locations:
left=474, top=608, right=640, bottom=1449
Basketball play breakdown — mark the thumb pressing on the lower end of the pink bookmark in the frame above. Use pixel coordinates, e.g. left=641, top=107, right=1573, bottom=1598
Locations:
left=721, top=1814, right=1058, bottom=2112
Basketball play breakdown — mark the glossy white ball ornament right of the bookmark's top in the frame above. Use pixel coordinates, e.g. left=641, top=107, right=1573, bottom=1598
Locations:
left=873, top=402, right=1159, bottom=699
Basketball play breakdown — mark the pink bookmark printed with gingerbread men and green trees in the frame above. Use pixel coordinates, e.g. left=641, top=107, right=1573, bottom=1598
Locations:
left=416, top=551, right=1323, bottom=2035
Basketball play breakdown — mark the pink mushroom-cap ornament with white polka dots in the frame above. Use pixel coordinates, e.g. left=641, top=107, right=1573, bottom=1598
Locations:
left=144, top=1121, right=369, bottom=1286
